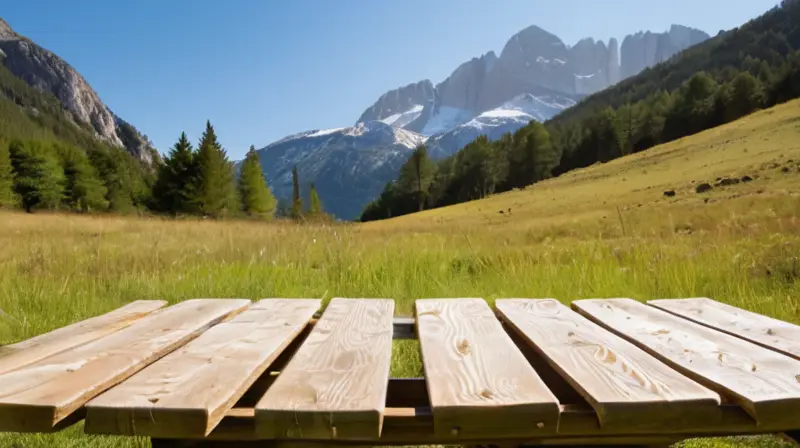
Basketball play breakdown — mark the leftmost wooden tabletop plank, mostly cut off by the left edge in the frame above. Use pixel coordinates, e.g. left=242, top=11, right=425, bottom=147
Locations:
left=0, top=300, right=167, bottom=374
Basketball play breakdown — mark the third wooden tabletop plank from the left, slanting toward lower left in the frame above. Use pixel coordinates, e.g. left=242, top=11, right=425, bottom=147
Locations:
left=85, top=299, right=321, bottom=438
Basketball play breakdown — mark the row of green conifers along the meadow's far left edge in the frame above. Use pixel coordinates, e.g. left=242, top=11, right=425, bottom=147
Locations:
left=0, top=122, right=327, bottom=220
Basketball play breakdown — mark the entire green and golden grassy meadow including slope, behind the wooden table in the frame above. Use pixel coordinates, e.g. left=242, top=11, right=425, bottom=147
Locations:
left=0, top=101, right=800, bottom=447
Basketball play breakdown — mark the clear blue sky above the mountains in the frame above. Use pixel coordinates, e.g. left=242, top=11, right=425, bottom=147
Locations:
left=0, top=0, right=778, bottom=159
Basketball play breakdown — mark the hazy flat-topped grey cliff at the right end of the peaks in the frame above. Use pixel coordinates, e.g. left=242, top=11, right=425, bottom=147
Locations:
left=620, top=25, right=711, bottom=79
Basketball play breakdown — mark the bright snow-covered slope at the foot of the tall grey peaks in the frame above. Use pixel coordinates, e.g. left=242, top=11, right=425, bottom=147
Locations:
left=429, top=93, right=575, bottom=154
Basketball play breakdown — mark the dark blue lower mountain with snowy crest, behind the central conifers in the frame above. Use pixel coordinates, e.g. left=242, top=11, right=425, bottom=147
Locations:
left=257, top=121, right=427, bottom=219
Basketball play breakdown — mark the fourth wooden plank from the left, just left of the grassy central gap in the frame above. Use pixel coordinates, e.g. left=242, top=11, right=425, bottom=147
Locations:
left=255, top=298, right=394, bottom=440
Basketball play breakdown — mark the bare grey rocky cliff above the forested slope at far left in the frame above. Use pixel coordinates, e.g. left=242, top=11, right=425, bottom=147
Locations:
left=0, top=19, right=157, bottom=164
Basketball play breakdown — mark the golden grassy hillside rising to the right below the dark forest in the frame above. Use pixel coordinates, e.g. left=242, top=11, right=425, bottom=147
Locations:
left=364, top=100, right=800, bottom=234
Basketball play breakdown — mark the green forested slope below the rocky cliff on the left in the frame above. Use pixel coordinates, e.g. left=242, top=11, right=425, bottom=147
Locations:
left=0, top=64, right=154, bottom=212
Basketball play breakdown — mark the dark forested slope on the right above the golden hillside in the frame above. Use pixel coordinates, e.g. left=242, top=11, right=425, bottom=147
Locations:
left=361, top=0, right=800, bottom=221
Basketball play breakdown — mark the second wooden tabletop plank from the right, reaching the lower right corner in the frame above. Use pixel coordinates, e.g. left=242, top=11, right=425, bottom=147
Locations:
left=573, top=299, right=800, bottom=425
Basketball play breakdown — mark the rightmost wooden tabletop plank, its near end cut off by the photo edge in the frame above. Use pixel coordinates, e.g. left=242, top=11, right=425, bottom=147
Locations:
left=647, top=297, right=800, bottom=359
